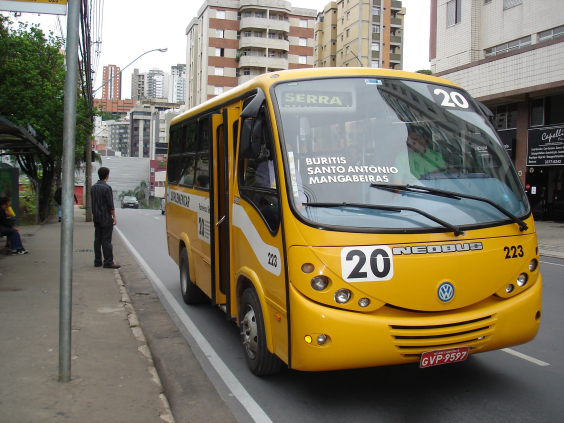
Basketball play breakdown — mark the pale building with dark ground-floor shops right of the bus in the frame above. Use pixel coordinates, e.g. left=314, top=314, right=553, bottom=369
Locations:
left=429, top=0, right=564, bottom=218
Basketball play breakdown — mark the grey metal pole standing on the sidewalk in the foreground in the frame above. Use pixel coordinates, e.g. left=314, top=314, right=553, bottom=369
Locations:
left=59, top=0, right=81, bottom=383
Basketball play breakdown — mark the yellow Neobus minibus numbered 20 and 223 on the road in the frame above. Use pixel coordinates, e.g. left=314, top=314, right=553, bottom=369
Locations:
left=166, top=68, right=541, bottom=375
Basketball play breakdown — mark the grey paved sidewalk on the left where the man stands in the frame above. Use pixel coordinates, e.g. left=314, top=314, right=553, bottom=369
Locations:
left=0, top=208, right=173, bottom=423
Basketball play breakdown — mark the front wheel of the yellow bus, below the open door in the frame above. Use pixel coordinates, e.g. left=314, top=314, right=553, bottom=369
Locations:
left=239, top=288, right=282, bottom=376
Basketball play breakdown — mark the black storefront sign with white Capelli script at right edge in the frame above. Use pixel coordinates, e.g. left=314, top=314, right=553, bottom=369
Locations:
left=527, top=125, right=564, bottom=166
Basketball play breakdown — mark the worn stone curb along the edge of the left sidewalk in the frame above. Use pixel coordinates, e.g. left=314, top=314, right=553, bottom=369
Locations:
left=114, top=269, right=175, bottom=423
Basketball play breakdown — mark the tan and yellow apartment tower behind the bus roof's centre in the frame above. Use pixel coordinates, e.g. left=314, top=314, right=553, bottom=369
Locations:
left=314, top=0, right=406, bottom=70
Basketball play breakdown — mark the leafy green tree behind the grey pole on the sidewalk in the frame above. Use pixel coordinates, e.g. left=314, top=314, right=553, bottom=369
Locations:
left=0, top=16, right=92, bottom=222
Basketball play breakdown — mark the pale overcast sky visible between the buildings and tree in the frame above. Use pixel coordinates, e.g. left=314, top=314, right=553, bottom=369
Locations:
left=4, top=0, right=430, bottom=99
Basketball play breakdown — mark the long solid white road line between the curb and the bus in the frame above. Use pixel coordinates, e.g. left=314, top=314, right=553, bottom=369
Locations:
left=115, top=227, right=272, bottom=423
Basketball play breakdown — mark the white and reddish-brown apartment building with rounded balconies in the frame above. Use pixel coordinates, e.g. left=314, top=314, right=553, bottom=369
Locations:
left=186, top=0, right=317, bottom=108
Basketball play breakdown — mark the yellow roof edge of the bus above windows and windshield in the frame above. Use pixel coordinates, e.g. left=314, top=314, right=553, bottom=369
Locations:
left=170, top=67, right=460, bottom=126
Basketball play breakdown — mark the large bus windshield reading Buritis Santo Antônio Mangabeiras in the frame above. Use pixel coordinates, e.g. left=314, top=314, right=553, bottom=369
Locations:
left=273, top=77, right=529, bottom=234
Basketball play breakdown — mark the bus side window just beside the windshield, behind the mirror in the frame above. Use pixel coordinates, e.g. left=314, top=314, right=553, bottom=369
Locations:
left=237, top=112, right=280, bottom=232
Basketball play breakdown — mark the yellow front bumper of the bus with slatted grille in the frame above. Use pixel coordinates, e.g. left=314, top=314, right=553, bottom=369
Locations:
left=290, top=275, right=542, bottom=371
